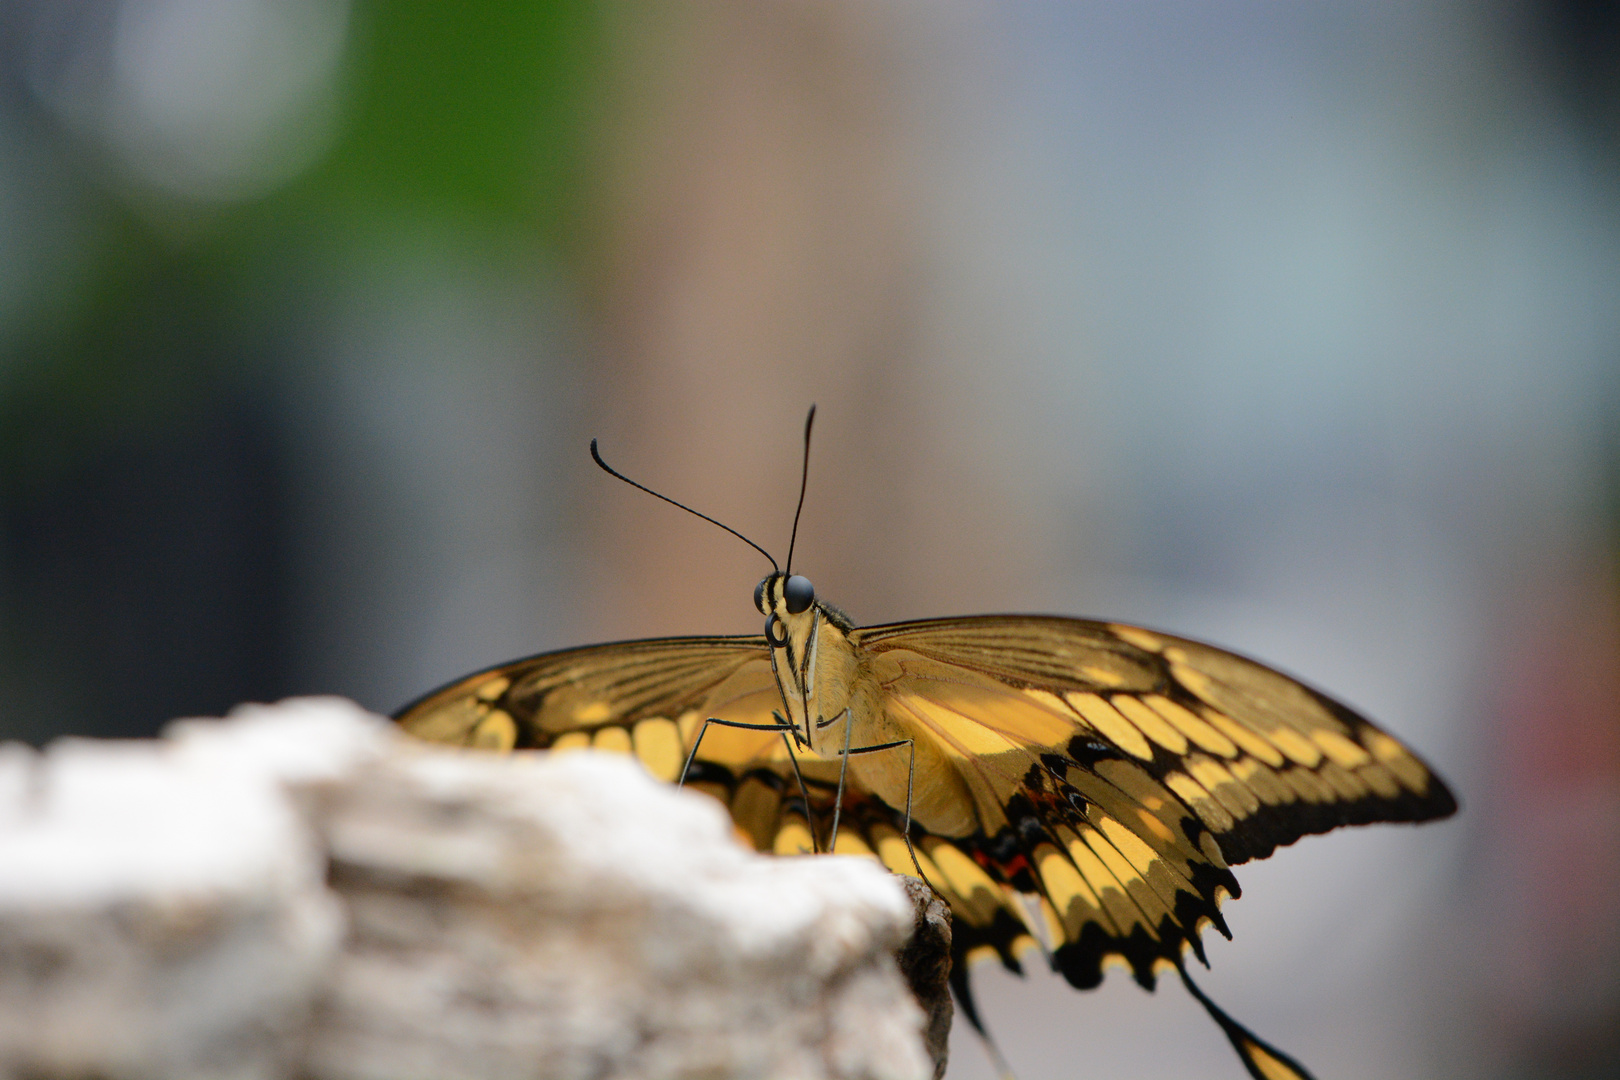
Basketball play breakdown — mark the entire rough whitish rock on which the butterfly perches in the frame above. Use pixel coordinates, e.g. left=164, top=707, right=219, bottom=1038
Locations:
left=0, top=699, right=949, bottom=1080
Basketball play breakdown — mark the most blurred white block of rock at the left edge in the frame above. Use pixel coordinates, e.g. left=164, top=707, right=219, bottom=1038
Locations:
left=0, top=702, right=359, bottom=1078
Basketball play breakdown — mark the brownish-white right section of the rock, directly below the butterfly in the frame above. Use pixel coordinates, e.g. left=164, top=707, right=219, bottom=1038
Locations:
left=311, top=750, right=933, bottom=1080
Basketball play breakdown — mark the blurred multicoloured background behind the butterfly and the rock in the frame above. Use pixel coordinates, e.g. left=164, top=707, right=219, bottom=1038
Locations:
left=0, top=0, right=1620, bottom=1080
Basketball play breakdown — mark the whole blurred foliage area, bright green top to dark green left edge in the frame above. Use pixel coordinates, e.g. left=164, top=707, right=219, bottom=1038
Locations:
left=0, top=0, right=604, bottom=482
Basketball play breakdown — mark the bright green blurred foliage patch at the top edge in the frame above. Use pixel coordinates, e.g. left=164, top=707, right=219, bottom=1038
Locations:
left=315, top=0, right=603, bottom=249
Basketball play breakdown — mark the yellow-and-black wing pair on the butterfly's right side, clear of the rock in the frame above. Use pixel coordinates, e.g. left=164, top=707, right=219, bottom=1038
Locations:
left=851, top=615, right=1456, bottom=997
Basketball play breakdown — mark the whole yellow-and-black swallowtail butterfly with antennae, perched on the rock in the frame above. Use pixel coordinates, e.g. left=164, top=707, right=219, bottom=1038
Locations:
left=395, top=406, right=1456, bottom=1080
